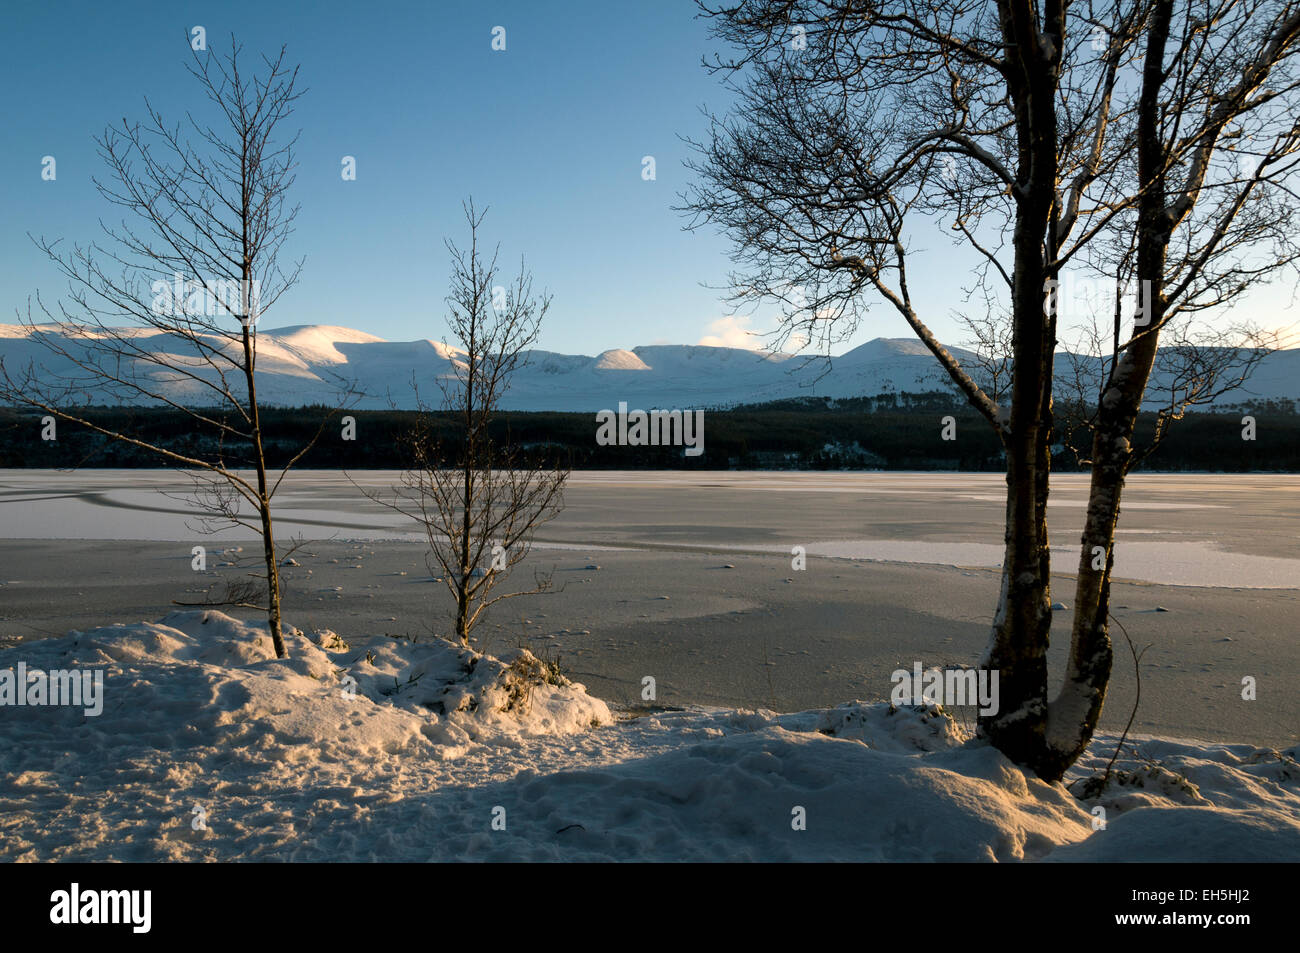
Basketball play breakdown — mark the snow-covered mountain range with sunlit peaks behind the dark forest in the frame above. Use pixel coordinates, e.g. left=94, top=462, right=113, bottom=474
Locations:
left=0, top=325, right=1300, bottom=412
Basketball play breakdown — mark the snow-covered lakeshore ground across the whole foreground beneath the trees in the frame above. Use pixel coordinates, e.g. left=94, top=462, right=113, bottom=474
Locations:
left=0, top=611, right=1300, bottom=861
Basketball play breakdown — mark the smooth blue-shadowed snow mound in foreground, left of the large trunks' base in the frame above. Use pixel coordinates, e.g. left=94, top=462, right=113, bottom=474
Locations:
left=467, top=705, right=1089, bottom=861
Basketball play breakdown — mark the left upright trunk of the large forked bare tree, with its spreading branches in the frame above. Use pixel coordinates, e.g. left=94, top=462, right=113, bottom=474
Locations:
left=686, top=0, right=1109, bottom=764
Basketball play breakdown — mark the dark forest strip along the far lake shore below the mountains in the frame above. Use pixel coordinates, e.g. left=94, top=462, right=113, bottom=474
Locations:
left=0, top=394, right=1300, bottom=473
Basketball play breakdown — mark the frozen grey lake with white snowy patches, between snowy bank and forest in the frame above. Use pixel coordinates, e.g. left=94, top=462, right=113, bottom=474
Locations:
left=0, top=471, right=1300, bottom=744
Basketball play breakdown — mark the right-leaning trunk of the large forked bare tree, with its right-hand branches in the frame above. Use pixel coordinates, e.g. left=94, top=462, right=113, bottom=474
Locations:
left=1047, top=0, right=1300, bottom=771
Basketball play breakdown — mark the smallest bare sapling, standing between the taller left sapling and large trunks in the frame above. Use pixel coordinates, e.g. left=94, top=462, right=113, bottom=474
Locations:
left=367, top=202, right=568, bottom=644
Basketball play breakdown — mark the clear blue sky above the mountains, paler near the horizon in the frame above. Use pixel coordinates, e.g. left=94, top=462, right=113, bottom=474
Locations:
left=0, top=0, right=1297, bottom=354
